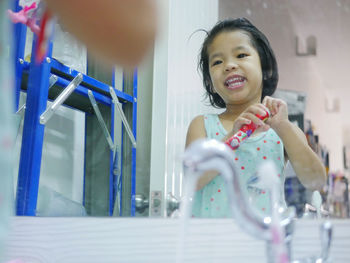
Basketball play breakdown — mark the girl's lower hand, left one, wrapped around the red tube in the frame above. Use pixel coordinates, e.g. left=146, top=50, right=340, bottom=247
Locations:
left=232, top=103, right=270, bottom=134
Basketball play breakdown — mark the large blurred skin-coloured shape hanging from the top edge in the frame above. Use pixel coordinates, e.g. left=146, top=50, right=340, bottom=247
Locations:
left=45, top=0, right=156, bottom=66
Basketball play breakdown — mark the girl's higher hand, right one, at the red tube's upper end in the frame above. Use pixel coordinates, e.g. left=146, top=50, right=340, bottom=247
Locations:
left=262, top=96, right=288, bottom=130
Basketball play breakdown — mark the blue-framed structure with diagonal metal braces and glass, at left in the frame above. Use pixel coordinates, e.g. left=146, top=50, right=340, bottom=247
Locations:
left=14, top=15, right=149, bottom=219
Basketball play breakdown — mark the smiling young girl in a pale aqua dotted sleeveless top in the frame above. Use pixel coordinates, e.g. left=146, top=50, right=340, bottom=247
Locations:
left=186, top=18, right=326, bottom=217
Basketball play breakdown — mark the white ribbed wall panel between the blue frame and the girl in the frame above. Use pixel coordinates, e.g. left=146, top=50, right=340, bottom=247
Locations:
left=150, top=0, right=218, bottom=216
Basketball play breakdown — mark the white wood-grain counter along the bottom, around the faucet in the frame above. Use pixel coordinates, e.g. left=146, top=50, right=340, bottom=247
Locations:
left=5, top=217, right=350, bottom=263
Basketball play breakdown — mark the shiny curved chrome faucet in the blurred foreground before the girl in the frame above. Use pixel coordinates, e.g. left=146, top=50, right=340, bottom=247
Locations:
left=180, top=139, right=331, bottom=263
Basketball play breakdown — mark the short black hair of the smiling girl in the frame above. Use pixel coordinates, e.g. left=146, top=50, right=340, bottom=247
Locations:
left=198, top=18, right=278, bottom=108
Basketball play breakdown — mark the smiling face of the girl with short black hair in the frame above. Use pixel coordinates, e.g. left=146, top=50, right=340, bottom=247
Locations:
left=208, top=30, right=262, bottom=105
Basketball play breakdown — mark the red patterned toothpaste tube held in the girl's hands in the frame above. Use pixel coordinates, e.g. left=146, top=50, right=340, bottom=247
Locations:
left=225, top=110, right=270, bottom=150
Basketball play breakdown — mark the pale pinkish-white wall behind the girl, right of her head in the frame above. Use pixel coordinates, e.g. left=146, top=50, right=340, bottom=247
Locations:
left=219, top=0, right=350, bottom=171
